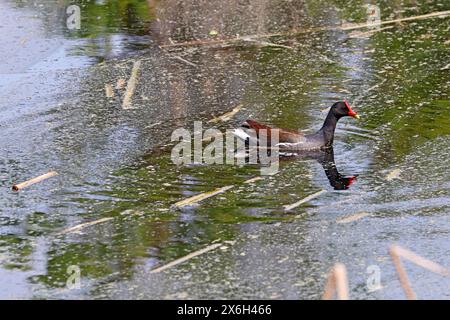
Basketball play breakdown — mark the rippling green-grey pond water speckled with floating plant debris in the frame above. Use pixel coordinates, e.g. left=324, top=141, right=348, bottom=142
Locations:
left=0, top=0, right=450, bottom=299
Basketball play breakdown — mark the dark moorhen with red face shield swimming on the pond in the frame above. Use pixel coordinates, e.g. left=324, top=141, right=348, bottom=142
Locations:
left=234, top=101, right=359, bottom=151
